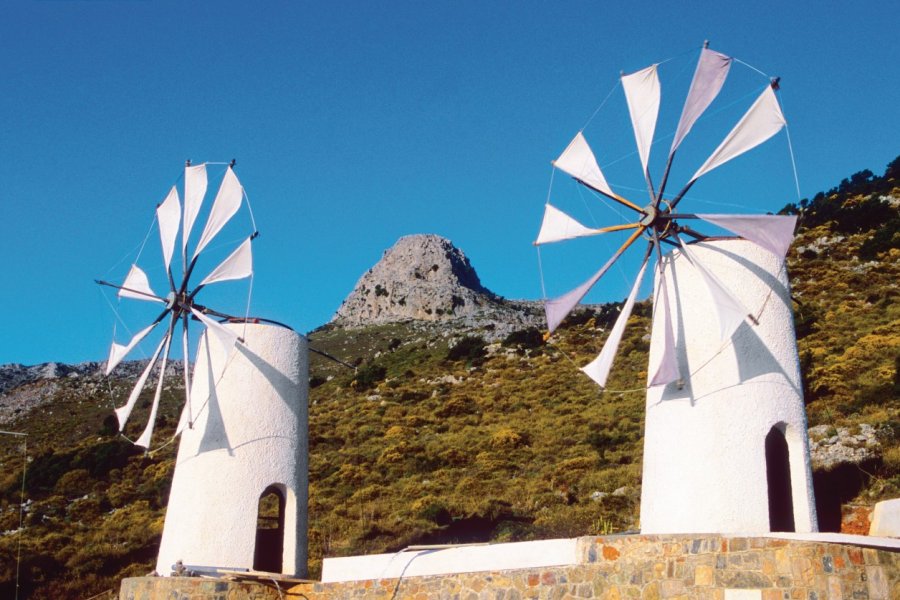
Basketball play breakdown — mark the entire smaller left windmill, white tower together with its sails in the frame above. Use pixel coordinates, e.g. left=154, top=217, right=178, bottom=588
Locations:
left=98, top=161, right=308, bottom=575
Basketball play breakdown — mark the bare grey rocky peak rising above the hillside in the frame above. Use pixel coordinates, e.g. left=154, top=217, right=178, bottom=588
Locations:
left=332, top=234, right=503, bottom=327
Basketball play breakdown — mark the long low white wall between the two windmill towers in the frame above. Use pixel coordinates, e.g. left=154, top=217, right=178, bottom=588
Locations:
left=322, top=538, right=578, bottom=582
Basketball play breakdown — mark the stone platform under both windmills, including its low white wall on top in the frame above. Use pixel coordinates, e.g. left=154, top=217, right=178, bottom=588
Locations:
left=119, top=534, right=900, bottom=600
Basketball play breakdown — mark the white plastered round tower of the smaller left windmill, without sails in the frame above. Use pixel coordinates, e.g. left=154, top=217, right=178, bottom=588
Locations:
left=156, top=324, right=308, bottom=576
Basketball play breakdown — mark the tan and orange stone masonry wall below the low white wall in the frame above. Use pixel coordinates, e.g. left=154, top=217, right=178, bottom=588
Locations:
left=120, top=535, right=900, bottom=600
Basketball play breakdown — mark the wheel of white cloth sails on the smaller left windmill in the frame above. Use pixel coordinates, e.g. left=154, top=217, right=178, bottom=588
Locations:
left=97, top=161, right=258, bottom=448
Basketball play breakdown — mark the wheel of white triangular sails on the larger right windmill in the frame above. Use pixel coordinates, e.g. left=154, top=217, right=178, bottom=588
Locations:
left=534, top=45, right=796, bottom=387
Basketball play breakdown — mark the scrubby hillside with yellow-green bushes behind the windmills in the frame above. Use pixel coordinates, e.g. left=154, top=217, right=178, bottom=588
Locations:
left=0, top=160, right=900, bottom=598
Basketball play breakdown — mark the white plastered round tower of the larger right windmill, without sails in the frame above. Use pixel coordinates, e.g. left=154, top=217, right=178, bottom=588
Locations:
left=641, top=240, right=817, bottom=533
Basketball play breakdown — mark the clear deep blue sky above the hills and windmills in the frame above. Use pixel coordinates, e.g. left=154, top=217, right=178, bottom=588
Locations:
left=0, top=1, right=900, bottom=364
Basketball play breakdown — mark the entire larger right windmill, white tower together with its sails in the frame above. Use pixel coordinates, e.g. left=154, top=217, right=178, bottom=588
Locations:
left=535, top=45, right=817, bottom=533
